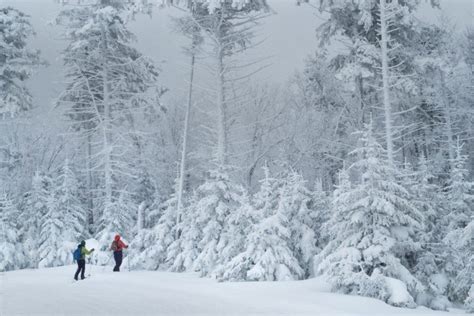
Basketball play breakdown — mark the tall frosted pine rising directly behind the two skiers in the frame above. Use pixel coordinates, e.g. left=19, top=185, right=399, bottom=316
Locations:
left=57, top=0, right=158, bottom=245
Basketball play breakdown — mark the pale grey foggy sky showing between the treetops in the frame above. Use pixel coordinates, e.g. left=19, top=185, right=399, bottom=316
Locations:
left=0, top=0, right=474, bottom=114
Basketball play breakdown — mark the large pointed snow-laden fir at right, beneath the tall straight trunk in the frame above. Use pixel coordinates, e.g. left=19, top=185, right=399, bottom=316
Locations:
left=317, top=124, right=423, bottom=306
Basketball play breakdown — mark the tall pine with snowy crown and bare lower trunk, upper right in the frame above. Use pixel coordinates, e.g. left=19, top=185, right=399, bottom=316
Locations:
left=312, top=0, right=436, bottom=164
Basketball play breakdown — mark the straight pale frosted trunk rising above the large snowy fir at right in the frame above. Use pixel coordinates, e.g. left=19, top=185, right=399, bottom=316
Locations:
left=380, top=0, right=393, bottom=166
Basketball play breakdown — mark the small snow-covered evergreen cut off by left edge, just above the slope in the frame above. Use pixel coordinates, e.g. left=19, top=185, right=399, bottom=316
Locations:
left=0, top=193, right=26, bottom=272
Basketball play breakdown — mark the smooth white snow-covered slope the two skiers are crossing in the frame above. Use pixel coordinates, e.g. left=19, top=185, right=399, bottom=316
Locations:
left=0, top=265, right=466, bottom=316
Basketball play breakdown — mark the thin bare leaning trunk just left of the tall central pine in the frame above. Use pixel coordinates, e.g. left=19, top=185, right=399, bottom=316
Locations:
left=176, top=52, right=196, bottom=239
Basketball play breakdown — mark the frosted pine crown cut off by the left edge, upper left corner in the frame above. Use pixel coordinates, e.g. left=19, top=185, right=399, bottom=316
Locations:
left=0, top=7, right=41, bottom=118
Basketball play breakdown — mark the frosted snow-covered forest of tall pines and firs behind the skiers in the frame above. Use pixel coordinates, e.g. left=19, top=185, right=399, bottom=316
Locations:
left=0, top=0, right=474, bottom=312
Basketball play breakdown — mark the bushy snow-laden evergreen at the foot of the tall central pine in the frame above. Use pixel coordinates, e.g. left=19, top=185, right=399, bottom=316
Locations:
left=166, top=168, right=245, bottom=275
